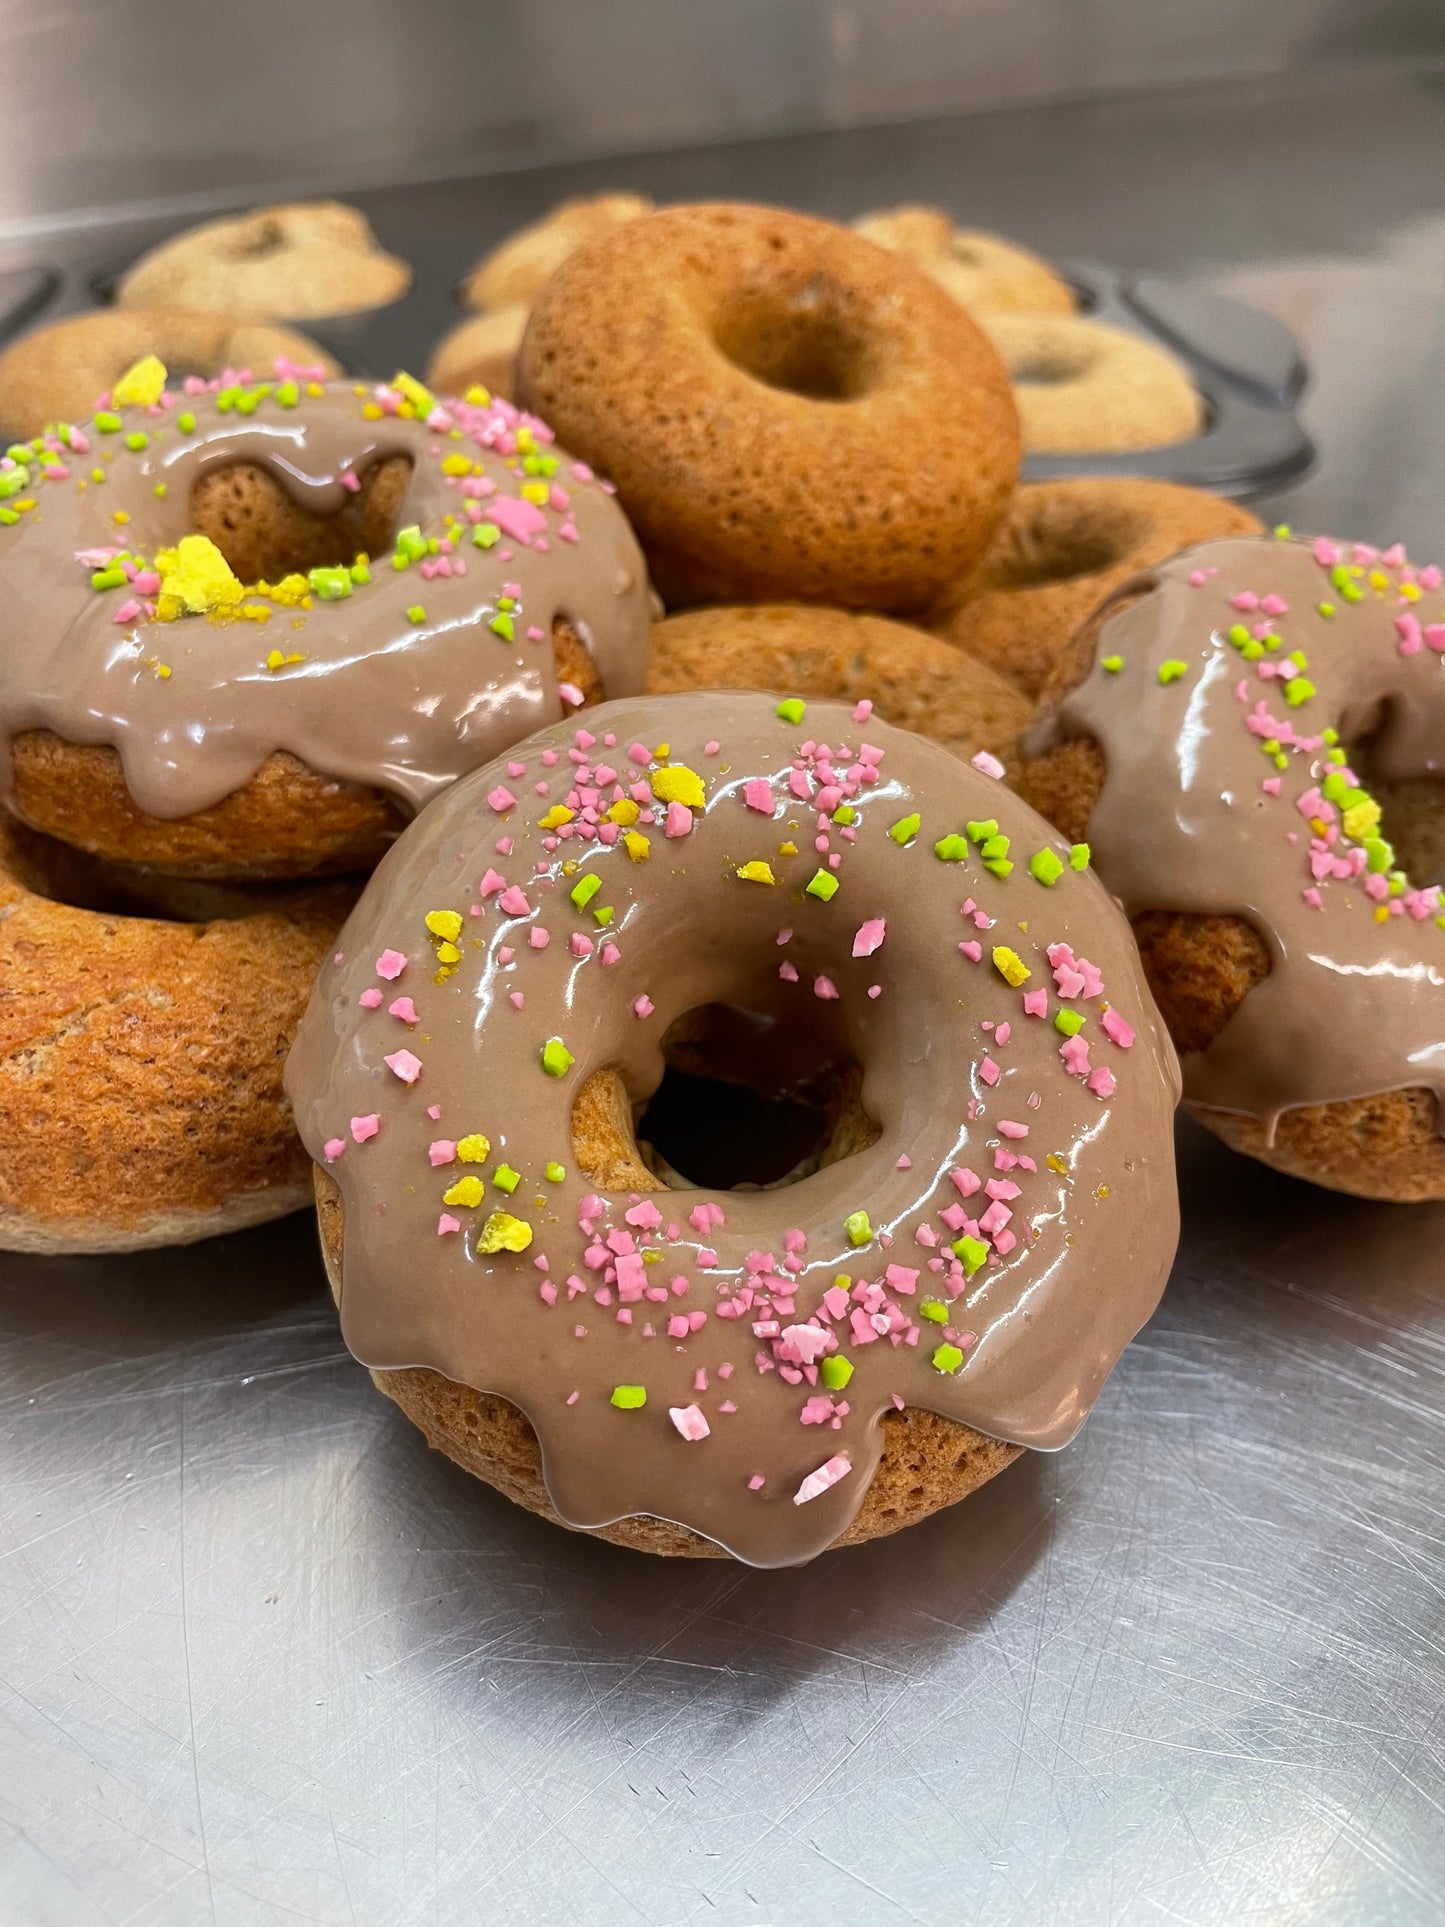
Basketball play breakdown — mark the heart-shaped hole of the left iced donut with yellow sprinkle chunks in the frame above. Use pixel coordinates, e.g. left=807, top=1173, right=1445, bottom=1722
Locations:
left=191, top=455, right=412, bottom=582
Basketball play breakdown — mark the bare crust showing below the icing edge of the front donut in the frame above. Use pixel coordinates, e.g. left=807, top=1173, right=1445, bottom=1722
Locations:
left=316, top=1168, right=1019, bottom=1559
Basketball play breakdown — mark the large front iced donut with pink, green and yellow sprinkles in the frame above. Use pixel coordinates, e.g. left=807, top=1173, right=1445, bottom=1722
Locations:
left=285, top=692, right=1177, bottom=1567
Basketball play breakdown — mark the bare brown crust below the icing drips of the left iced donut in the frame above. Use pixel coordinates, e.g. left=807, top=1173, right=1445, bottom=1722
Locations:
left=12, top=620, right=603, bottom=881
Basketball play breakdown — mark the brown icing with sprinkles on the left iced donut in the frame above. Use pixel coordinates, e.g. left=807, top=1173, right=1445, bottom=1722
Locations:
left=0, top=375, right=649, bottom=817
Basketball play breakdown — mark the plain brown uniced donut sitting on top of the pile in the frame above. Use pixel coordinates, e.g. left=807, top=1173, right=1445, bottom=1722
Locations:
left=516, top=204, right=1019, bottom=613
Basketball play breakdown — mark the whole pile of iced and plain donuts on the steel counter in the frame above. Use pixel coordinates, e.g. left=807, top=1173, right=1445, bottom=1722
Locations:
left=0, top=181, right=1445, bottom=1565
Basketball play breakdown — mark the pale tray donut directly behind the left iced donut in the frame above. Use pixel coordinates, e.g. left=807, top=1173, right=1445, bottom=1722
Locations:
left=0, top=308, right=341, bottom=441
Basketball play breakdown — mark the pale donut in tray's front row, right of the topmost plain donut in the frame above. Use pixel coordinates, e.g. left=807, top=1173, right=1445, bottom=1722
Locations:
left=979, top=314, right=1204, bottom=455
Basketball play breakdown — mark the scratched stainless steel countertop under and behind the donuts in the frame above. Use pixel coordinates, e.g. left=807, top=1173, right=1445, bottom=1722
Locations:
left=0, top=64, right=1445, bottom=1927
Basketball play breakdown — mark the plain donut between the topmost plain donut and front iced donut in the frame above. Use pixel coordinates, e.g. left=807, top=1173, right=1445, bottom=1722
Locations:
left=647, top=603, right=1033, bottom=771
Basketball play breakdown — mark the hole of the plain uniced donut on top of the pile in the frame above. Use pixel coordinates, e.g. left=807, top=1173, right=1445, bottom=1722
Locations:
left=713, top=276, right=873, bottom=401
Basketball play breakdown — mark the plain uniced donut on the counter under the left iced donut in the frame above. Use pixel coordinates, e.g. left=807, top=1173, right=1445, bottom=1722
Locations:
left=0, top=813, right=355, bottom=1253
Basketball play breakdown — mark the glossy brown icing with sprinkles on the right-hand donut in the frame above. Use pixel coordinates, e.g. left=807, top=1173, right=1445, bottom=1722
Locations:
left=1033, top=538, right=1445, bottom=1129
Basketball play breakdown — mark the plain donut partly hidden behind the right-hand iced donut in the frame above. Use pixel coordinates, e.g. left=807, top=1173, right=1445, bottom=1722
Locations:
left=929, top=476, right=1262, bottom=698
